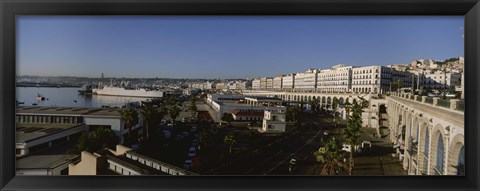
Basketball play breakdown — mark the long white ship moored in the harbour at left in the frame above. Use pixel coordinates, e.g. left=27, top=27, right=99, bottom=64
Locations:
left=92, top=86, right=164, bottom=98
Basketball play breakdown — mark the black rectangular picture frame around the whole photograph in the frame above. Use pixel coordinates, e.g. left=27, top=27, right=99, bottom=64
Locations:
left=0, top=0, right=480, bottom=191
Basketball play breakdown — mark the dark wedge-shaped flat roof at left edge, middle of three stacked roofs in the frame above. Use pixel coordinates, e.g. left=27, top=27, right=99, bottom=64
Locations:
left=15, top=123, right=83, bottom=143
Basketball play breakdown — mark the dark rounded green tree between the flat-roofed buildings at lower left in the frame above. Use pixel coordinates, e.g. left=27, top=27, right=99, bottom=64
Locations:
left=77, top=127, right=119, bottom=152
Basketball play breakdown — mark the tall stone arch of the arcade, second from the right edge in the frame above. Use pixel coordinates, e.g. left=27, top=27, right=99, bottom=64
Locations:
left=428, top=124, right=448, bottom=175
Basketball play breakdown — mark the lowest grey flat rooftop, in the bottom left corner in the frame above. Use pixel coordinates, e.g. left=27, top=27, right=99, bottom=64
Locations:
left=16, top=155, right=80, bottom=169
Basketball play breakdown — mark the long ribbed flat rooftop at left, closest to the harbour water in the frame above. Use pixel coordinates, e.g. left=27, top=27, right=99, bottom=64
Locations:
left=16, top=106, right=121, bottom=116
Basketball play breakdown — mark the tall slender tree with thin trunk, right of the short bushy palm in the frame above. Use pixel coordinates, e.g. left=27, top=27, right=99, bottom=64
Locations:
left=345, top=101, right=363, bottom=175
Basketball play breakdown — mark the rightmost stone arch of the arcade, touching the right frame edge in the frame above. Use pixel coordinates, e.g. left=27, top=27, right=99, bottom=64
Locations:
left=447, top=135, right=465, bottom=175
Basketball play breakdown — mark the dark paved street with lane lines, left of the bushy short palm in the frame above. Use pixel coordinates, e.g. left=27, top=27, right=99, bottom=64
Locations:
left=208, top=113, right=327, bottom=175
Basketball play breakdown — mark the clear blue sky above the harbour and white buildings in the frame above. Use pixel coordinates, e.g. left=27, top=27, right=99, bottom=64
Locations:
left=16, top=16, right=464, bottom=79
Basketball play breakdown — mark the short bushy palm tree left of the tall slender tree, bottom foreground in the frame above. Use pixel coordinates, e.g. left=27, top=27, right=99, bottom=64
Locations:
left=314, top=139, right=346, bottom=175
